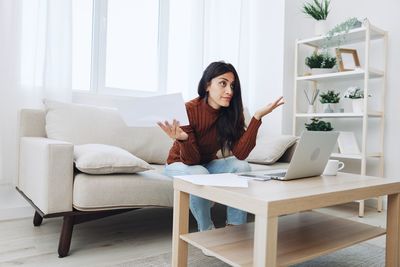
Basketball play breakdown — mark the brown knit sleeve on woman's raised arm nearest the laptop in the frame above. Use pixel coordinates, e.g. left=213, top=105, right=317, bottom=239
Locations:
left=232, top=117, right=261, bottom=160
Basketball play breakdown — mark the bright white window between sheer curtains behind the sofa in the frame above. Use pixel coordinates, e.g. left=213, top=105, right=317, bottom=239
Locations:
left=72, top=0, right=168, bottom=94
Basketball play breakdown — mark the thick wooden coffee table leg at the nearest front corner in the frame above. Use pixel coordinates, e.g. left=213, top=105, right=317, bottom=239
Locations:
left=253, top=215, right=278, bottom=267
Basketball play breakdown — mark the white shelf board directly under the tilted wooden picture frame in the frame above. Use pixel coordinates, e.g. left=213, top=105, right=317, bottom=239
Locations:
left=296, top=68, right=384, bottom=81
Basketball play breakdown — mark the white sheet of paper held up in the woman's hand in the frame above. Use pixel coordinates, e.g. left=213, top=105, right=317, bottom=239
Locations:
left=118, top=93, right=189, bottom=127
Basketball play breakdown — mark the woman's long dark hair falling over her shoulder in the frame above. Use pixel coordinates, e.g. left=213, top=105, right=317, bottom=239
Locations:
left=197, top=61, right=245, bottom=156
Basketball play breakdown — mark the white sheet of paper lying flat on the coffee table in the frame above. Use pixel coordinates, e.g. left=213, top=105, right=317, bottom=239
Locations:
left=174, top=173, right=249, bottom=187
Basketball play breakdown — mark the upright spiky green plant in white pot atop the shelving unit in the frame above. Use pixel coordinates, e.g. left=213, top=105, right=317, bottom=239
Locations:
left=302, top=0, right=330, bottom=35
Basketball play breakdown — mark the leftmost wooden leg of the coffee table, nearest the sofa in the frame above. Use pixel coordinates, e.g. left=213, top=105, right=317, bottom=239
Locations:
left=172, top=190, right=189, bottom=267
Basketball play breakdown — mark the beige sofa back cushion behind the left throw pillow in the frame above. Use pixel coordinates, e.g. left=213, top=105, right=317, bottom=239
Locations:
left=44, top=100, right=172, bottom=164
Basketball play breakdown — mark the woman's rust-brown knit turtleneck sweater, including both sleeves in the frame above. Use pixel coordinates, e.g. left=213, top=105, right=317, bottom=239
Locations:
left=167, top=98, right=261, bottom=165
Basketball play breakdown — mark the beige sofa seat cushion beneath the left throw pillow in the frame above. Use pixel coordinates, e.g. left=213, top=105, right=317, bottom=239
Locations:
left=73, top=170, right=174, bottom=210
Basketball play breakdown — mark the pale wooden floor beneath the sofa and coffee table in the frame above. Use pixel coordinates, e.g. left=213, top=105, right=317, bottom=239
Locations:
left=0, top=203, right=386, bottom=267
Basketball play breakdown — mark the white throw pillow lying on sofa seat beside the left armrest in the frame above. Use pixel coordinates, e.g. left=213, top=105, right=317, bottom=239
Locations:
left=74, top=144, right=153, bottom=174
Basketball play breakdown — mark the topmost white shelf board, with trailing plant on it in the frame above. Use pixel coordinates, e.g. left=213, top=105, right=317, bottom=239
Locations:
left=297, top=25, right=385, bottom=48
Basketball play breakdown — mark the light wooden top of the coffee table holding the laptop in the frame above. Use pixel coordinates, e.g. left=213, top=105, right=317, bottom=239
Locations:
left=174, top=173, right=400, bottom=216
